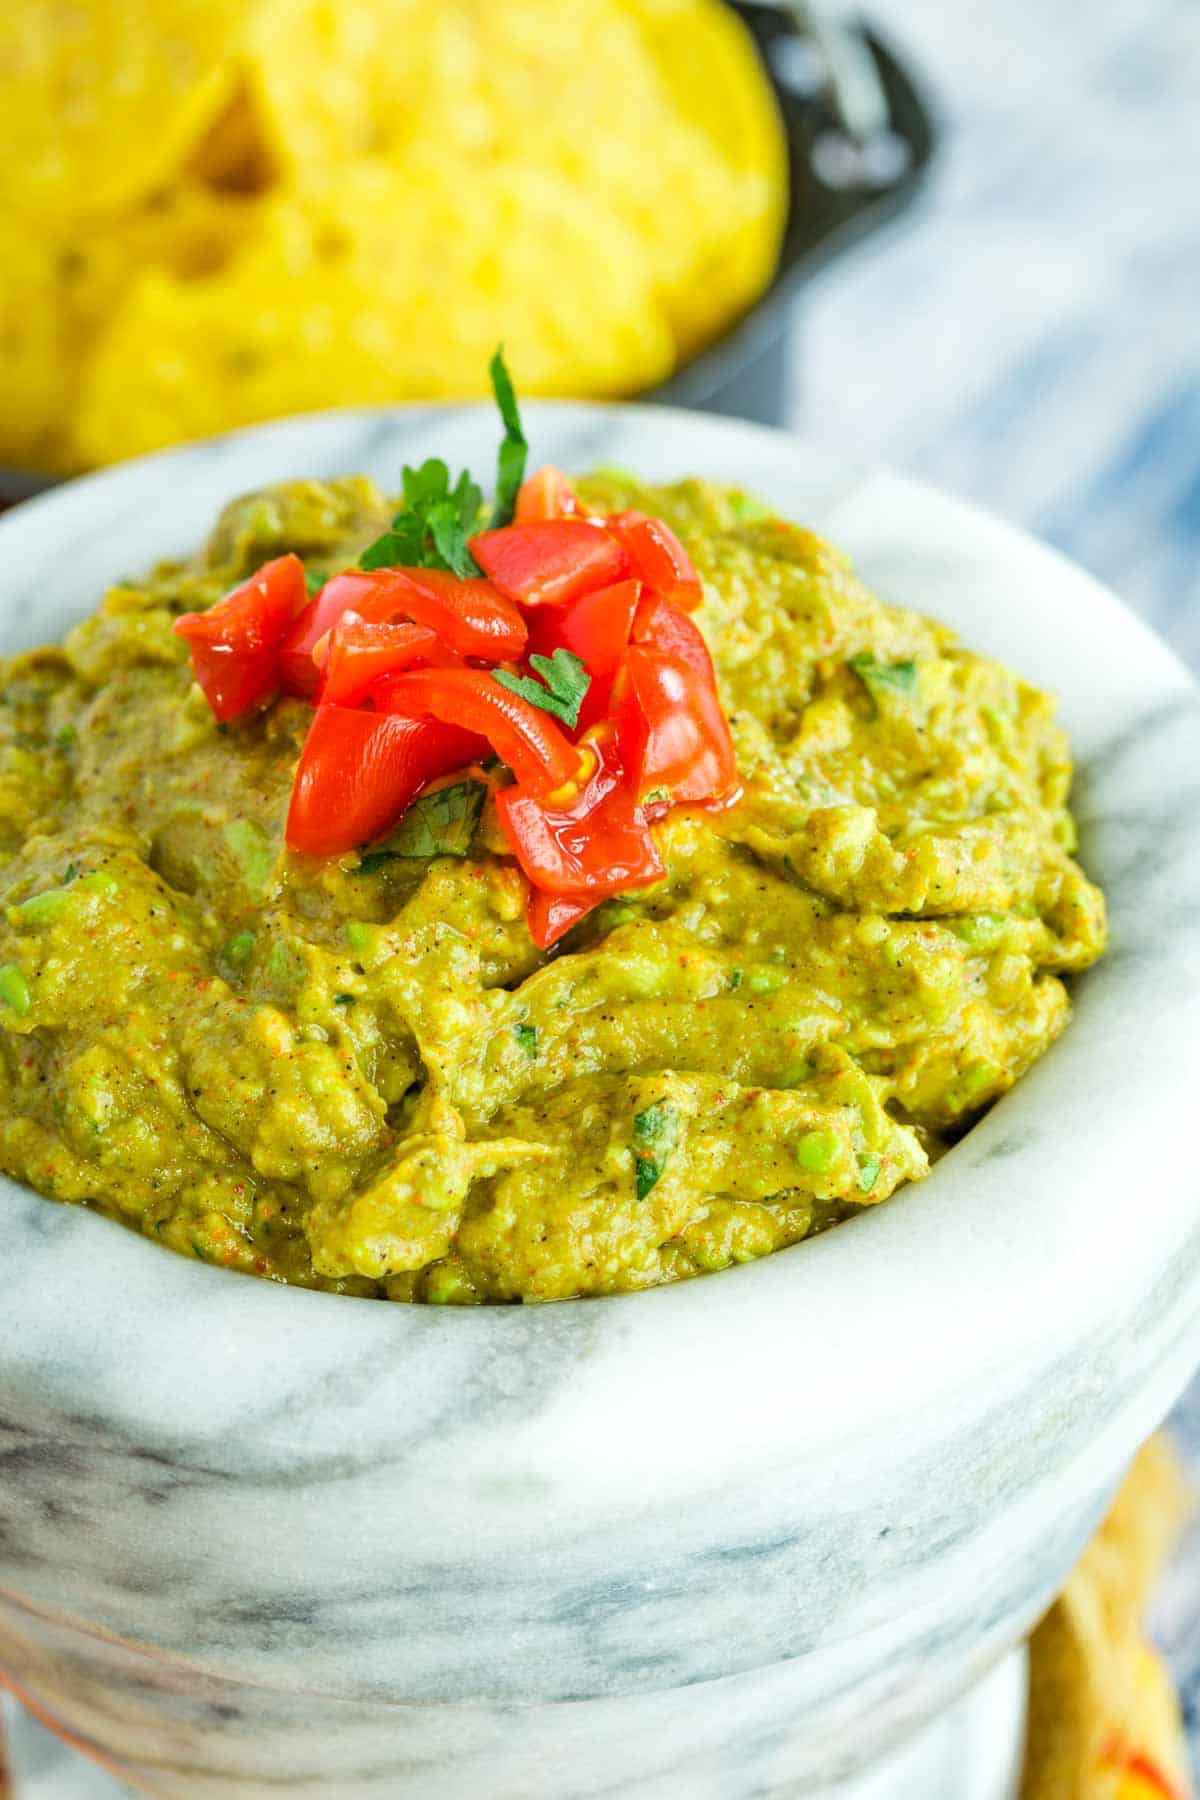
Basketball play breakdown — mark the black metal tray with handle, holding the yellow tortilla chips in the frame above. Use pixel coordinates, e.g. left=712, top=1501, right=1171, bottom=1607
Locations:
left=0, top=15, right=936, bottom=508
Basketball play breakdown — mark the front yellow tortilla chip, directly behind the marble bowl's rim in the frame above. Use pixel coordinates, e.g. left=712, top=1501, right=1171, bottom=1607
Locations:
left=72, top=162, right=675, bottom=463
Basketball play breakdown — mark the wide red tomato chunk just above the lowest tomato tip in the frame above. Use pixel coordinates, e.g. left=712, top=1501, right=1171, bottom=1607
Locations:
left=497, top=731, right=664, bottom=898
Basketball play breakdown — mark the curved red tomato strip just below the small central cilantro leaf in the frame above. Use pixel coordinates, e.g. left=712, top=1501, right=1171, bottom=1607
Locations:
left=376, top=670, right=579, bottom=794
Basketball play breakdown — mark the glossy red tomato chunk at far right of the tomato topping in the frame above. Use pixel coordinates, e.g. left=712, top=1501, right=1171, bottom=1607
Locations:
left=613, top=644, right=738, bottom=805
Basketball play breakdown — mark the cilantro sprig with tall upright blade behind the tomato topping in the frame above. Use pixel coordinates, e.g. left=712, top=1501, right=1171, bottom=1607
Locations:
left=358, top=349, right=529, bottom=581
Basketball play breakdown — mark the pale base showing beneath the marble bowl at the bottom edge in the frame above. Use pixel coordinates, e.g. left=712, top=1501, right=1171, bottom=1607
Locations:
left=2, top=1651, right=1025, bottom=1800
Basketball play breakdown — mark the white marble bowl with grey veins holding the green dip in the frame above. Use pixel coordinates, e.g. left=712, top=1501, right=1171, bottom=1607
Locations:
left=0, top=407, right=1200, bottom=1800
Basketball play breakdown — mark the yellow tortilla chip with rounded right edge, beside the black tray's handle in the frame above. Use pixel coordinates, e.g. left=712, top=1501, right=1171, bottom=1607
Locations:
left=239, top=0, right=788, bottom=365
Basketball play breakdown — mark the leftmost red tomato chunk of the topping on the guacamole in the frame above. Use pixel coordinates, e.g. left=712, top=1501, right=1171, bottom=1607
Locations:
left=175, top=554, right=308, bottom=724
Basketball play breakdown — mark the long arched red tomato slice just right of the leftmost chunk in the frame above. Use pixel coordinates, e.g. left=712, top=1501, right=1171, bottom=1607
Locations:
left=281, top=569, right=527, bottom=698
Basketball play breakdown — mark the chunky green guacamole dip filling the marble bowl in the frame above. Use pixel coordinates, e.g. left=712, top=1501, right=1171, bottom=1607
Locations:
left=0, top=475, right=1105, bottom=1303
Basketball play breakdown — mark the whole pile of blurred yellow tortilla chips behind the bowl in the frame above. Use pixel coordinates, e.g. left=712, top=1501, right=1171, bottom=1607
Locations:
left=0, top=0, right=788, bottom=470
